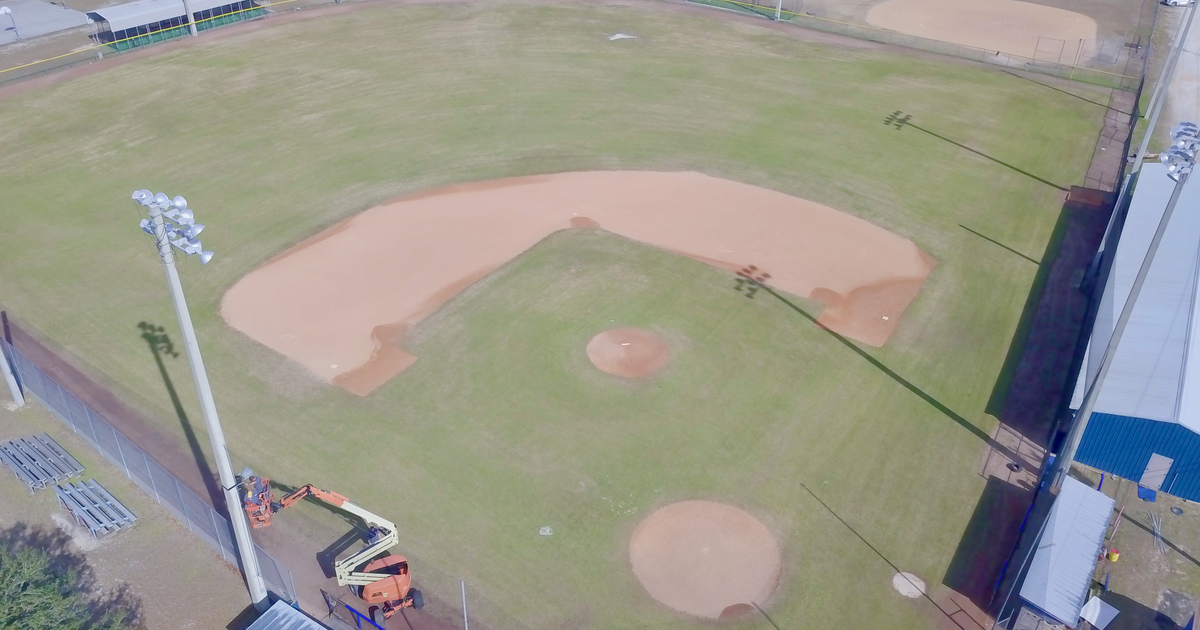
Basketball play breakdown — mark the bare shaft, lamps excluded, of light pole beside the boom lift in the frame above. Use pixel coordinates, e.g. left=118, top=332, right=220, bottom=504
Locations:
left=146, top=204, right=271, bottom=612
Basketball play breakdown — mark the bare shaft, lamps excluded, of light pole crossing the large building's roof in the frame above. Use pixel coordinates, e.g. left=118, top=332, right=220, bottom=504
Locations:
left=1050, top=166, right=1188, bottom=492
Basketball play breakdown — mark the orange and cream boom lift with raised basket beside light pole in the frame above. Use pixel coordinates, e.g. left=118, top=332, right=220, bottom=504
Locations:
left=241, top=472, right=425, bottom=619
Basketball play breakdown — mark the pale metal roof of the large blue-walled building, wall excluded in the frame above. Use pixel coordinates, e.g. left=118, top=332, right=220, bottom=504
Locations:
left=1072, top=163, right=1200, bottom=431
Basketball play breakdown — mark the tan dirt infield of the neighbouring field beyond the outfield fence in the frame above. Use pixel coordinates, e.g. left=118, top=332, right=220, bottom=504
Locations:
left=866, top=0, right=1097, bottom=60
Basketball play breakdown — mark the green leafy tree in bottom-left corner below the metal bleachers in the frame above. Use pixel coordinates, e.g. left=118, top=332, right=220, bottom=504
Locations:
left=0, top=522, right=143, bottom=629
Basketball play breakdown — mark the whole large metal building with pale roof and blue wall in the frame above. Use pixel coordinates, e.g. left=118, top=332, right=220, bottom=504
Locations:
left=1070, top=163, right=1200, bottom=500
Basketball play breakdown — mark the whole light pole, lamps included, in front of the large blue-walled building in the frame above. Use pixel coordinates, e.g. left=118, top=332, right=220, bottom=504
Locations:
left=1050, top=122, right=1200, bottom=491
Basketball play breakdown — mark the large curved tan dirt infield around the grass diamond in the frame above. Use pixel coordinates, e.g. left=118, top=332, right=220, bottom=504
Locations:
left=221, top=172, right=934, bottom=395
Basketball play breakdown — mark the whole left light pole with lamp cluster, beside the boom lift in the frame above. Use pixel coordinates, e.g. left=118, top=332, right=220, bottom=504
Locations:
left=133, top=191, right=271, bottom=612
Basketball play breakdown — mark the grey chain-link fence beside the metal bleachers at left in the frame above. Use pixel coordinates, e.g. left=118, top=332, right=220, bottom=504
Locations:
left=0, top=337, right=296, bottom=602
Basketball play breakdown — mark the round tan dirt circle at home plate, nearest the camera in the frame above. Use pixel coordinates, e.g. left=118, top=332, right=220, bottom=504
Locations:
left=629, top=500, right=782, bottom=619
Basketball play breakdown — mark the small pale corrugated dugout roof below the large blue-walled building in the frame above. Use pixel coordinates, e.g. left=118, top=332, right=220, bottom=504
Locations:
left=1021, top=478, right=1115, bottom=628
